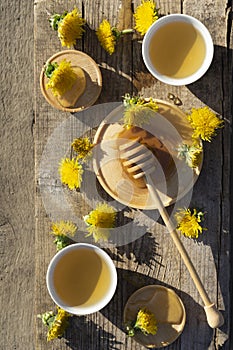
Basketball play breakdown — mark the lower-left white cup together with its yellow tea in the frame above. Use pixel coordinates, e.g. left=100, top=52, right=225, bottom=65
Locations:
left=47, top=243, right=117, bottom=315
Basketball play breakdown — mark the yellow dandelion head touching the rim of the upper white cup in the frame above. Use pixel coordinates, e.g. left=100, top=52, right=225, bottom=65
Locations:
left=134, top=0, right=159, bottom=35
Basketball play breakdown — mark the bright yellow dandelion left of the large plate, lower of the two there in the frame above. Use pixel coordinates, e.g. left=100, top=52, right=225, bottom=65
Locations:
left=59, top=158, right=83, bottom=190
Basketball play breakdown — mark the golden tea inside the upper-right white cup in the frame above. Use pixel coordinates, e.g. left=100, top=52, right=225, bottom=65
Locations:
left=149, top=22, right=206, bottom=79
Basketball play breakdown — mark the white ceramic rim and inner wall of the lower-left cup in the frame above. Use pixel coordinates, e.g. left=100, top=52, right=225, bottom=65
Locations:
left=46, top=243, right=117, bottom=316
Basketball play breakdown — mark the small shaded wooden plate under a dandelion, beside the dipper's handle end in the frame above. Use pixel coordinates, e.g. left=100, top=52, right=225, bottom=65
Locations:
left=123, top=285, right=186, bottom=348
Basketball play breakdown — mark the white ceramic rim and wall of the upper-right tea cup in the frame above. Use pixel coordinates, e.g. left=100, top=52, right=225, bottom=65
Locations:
left=142, top=14, right=214, bottom=86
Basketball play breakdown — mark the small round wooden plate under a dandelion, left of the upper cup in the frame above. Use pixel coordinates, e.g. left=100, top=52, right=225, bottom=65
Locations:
left=40, top=50, right=102, bottom=112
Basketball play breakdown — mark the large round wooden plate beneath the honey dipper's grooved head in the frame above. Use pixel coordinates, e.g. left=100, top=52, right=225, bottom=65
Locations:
left=93, top=100, right=202, bottom=209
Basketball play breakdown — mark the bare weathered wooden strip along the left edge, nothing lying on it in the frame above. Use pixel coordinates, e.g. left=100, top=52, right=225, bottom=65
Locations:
left=0, top=1, right=35, bottom=349
